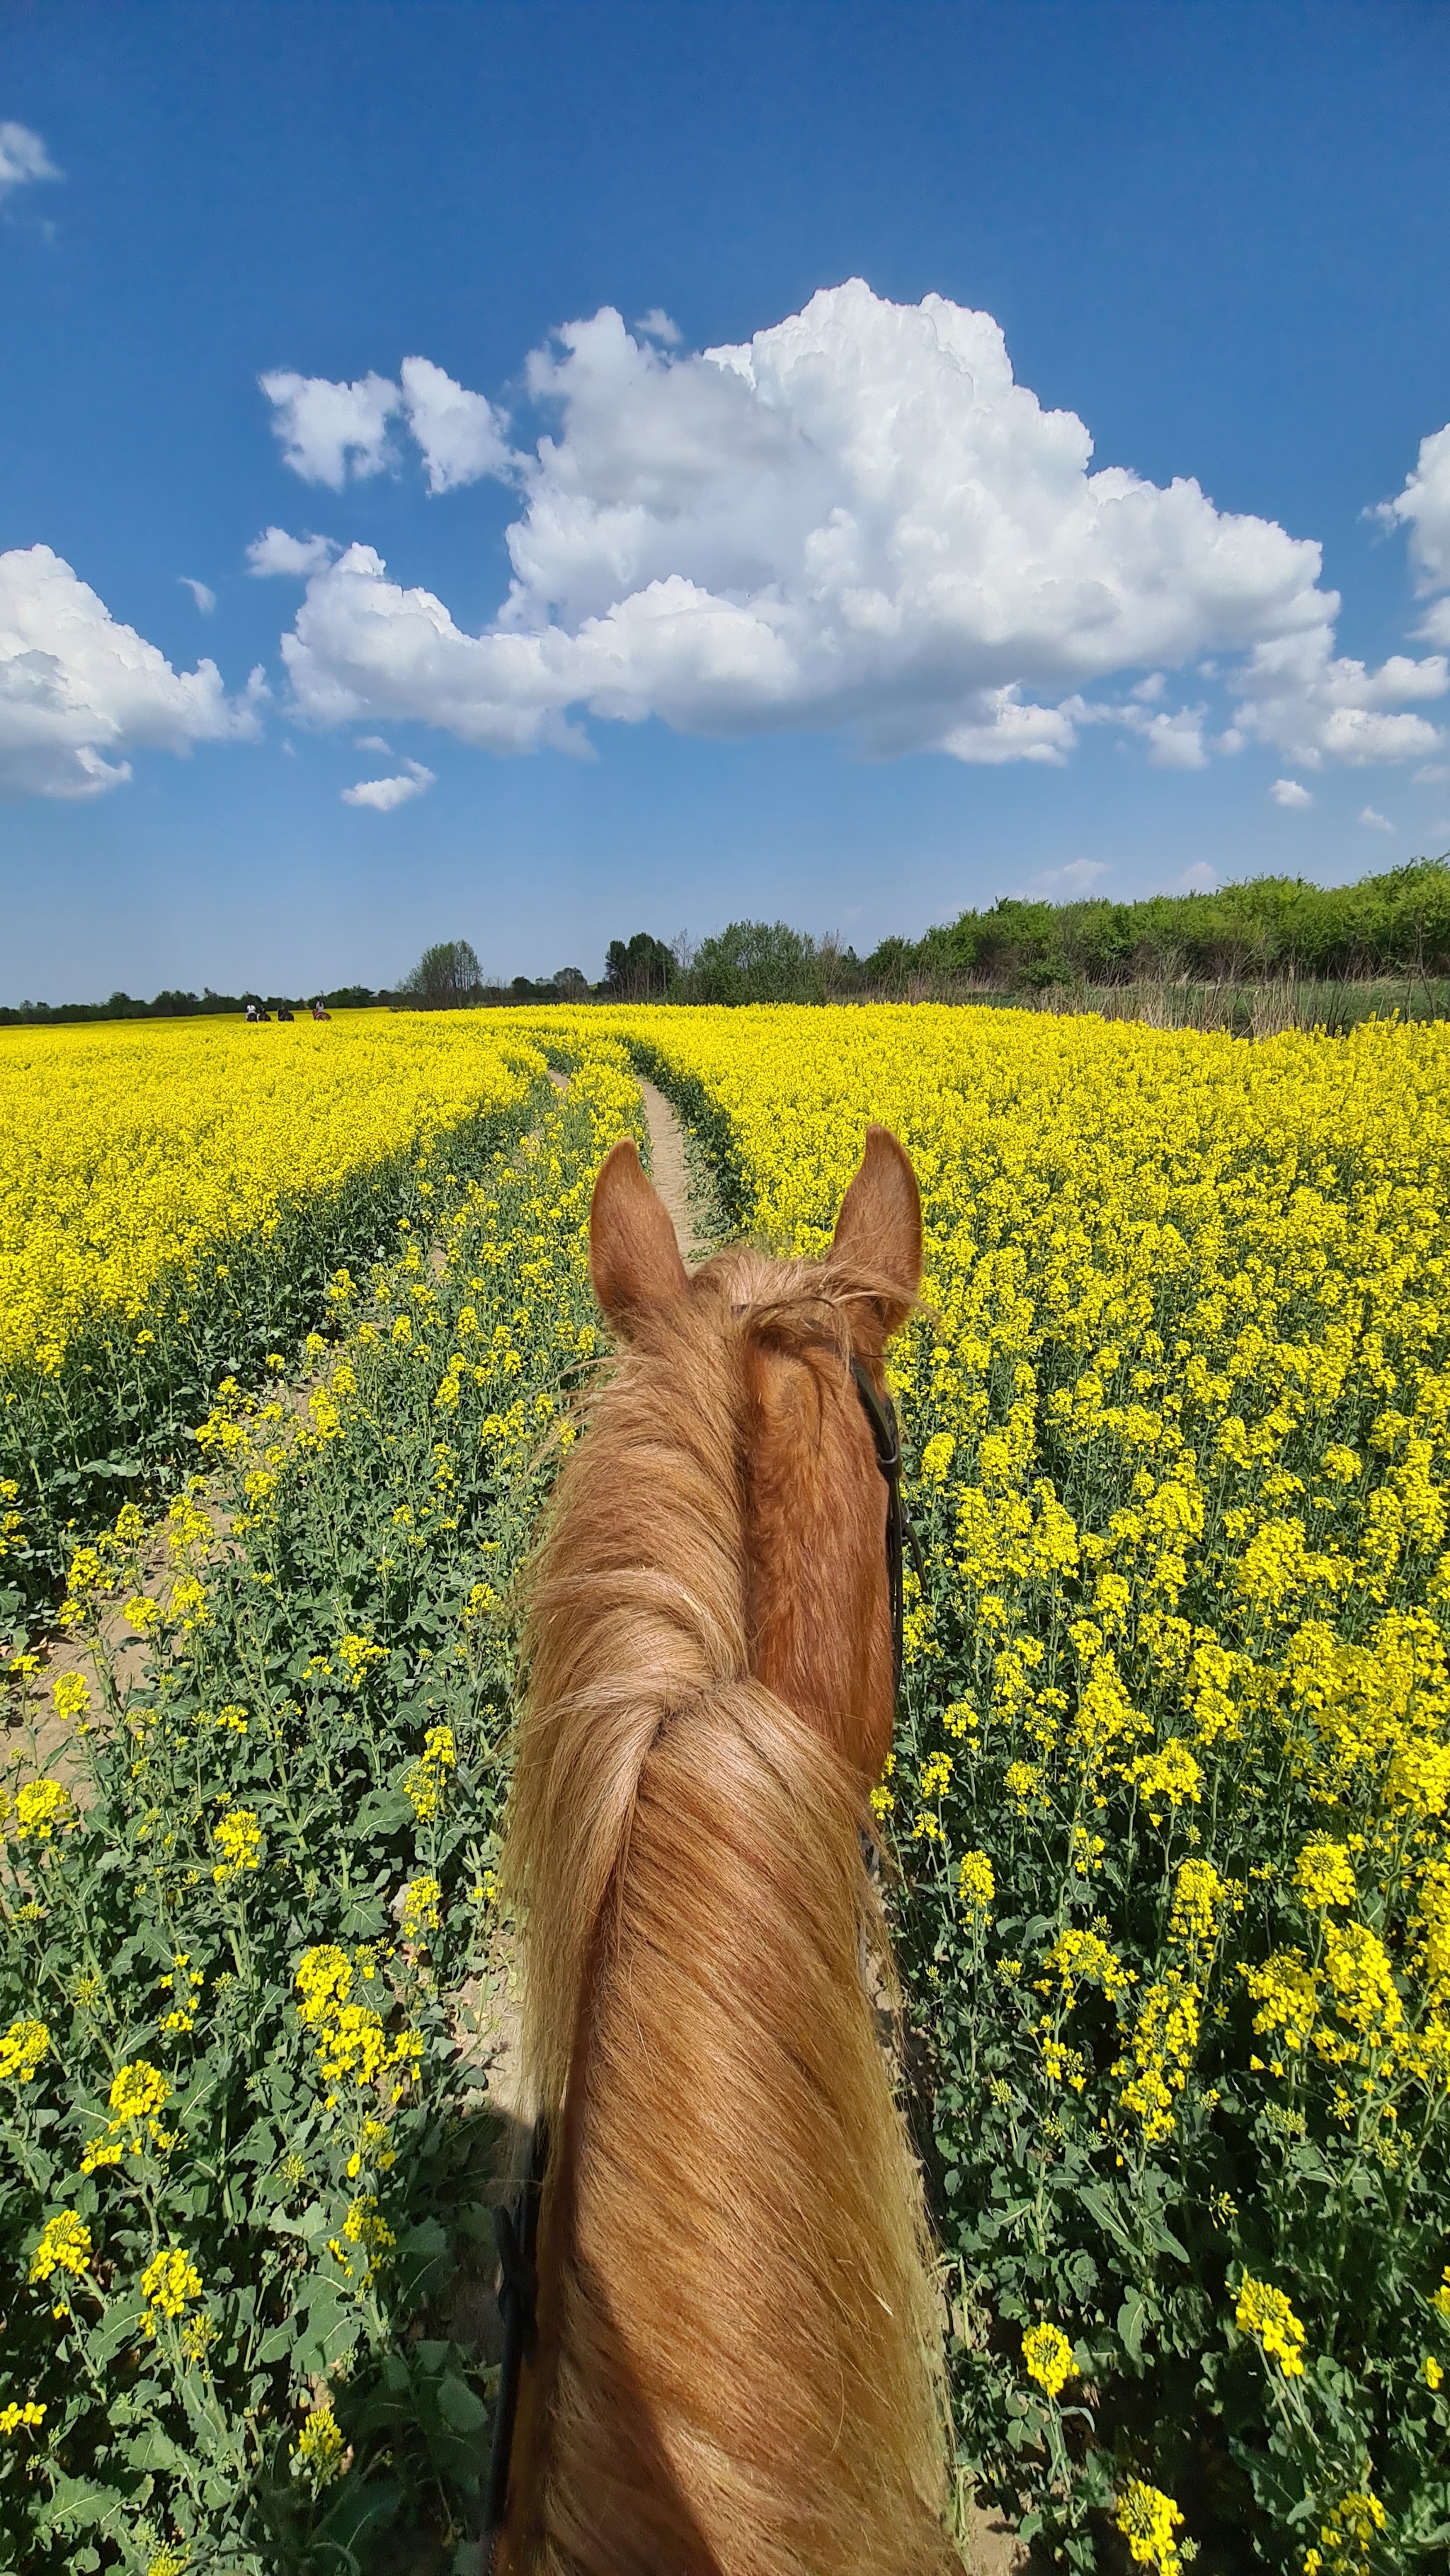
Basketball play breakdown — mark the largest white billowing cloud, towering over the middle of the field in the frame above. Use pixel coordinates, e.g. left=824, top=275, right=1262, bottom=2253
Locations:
left=268, top=278, right=1450, bottom=770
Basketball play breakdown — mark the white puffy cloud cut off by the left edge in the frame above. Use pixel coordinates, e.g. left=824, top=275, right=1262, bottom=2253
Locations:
left=0, top=546, right=266, bottom=796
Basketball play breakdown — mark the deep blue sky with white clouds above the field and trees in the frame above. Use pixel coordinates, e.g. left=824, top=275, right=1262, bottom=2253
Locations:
left=0, top=0, right=1450, bottom=1002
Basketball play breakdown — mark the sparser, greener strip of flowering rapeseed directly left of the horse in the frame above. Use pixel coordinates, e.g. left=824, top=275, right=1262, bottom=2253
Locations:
left=0, top=1030, right=639, bottom=2576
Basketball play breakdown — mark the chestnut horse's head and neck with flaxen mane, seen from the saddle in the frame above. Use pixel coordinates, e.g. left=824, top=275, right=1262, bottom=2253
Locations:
left=494, top=1126, right=958, bottom=2576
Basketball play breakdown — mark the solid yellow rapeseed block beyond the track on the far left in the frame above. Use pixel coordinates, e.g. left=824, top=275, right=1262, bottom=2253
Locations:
left=0, top=1013, right=544, bottom=1587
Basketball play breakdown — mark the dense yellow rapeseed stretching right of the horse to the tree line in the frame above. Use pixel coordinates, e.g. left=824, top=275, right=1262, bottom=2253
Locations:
left=584, top=1007, right=1450, bottom=2576
